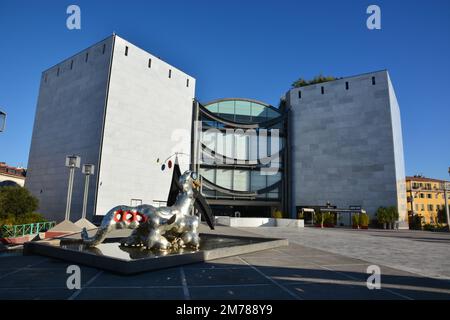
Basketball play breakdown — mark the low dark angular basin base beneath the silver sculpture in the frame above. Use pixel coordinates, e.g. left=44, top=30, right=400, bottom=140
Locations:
left=24, top=230, right=288, bottom=274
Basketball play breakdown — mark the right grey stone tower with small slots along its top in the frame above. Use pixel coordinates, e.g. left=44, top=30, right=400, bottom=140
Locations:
left=287, top=71, right=406, bottom=225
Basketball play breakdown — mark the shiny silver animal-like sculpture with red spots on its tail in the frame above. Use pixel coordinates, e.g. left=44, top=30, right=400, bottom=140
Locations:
left=81, top=171, right=209, bottom=251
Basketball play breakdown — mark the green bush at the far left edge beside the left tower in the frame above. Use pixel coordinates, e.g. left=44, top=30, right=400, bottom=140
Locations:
left=0, top=187, right=40, bottom=224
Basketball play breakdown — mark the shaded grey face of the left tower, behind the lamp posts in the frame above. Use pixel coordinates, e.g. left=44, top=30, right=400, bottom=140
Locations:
left=25, top=37, right=112, bottom=221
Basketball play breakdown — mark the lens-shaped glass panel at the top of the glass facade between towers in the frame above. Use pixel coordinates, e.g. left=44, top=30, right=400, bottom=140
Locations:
left=204, top=98, right=281, bottom=123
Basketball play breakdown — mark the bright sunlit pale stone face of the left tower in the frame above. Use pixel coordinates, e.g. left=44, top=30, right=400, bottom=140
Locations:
left=96, top=36, right=195, bottom=215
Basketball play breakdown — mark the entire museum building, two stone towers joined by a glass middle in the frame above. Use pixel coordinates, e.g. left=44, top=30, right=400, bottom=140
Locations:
left=25, top=34, right=407, bottom=226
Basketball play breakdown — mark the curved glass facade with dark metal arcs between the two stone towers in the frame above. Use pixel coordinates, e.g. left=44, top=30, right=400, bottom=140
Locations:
left=194, top=99, right=286, bottom=216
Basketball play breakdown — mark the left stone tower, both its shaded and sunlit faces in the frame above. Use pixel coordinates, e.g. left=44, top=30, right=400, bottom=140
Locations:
left=26, top=35, right=195, bottom=221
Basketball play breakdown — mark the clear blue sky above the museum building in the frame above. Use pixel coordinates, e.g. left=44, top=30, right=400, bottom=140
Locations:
left=0, top=0, right=450, bottom=179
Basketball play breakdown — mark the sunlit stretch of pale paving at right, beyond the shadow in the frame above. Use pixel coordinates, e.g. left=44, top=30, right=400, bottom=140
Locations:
left=246, top=227, right=450, bottom=280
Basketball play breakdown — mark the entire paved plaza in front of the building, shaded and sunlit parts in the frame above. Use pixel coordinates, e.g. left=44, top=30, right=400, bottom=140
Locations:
left=0, top=227, right=450, bottom=300
